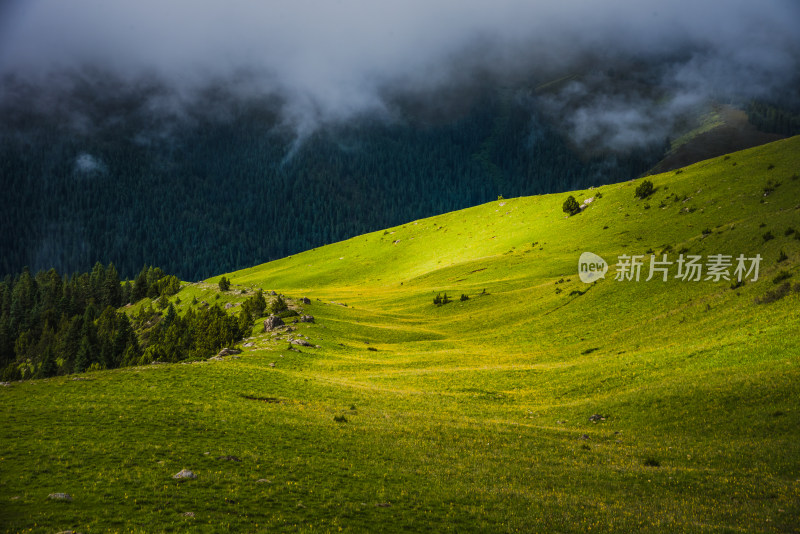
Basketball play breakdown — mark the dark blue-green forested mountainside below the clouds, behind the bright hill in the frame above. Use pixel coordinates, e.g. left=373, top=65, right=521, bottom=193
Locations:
left=0, top=80, right=664, bottom=280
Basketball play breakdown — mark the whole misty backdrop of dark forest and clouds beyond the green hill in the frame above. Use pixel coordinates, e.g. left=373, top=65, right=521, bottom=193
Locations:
left=0, top=0, right=800, bottom=279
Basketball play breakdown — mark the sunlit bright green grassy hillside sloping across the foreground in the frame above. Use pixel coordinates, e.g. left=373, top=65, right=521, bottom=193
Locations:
left=0, top=137, right=800, bottom=532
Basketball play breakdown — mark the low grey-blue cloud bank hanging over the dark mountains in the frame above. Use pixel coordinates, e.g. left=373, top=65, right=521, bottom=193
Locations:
left=0, top=0, right=800, bottom=151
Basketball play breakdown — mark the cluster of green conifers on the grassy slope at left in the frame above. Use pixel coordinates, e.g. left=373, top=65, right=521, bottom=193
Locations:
left=0, top=263, right=247, bottom=380
